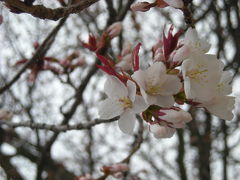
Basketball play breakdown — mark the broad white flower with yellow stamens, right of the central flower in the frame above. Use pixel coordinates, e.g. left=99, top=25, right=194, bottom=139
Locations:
left=181, top=53, right=223, bottom=101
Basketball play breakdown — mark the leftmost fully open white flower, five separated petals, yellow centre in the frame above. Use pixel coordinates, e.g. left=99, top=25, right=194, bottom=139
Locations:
left=98, top=76, right=148, bottom=134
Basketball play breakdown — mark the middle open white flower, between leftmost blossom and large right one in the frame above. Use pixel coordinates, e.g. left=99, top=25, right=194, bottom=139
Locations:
left=132, top=62, right=182, bottom=107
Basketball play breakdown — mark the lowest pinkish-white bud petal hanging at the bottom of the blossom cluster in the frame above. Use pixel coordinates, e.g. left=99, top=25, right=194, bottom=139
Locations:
left=149, top=124, right=176, bottom=138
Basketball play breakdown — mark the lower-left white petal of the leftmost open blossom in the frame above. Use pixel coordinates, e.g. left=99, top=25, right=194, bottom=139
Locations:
left=98, top=98, right=124, bottom=119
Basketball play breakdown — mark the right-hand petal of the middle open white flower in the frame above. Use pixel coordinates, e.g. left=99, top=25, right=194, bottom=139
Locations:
left=160, top=75, right=182, bottom=96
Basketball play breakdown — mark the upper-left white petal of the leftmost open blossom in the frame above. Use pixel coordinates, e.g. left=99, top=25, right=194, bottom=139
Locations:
left=104, top=76, right=128, bottom=98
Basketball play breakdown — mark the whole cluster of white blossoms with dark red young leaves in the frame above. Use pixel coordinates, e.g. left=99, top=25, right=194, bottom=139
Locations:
left=97, top=26, right=235, bottom=138
